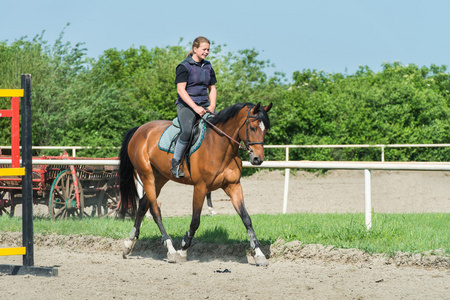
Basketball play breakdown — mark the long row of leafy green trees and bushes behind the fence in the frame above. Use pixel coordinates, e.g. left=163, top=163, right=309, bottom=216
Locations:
left=0, top=31, right=450, bottom=161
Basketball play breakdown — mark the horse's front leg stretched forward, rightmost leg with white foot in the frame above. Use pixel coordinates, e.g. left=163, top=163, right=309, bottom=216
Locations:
left=224, top=183, right=269, bottom=266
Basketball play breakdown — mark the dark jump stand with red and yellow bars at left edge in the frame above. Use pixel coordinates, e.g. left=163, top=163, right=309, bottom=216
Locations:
left=0, top=74, right=58, bottom=276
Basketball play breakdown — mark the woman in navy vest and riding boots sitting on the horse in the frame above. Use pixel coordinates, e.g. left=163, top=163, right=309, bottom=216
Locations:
left=170, top=36, right=217, bottom=178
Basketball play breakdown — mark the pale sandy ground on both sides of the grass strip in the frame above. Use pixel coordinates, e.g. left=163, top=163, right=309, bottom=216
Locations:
left=0, top=171, right=450, bottom=299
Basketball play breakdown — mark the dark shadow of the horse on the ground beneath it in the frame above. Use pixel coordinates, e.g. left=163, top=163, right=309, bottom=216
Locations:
left=126, top=226, right=270, bottom=263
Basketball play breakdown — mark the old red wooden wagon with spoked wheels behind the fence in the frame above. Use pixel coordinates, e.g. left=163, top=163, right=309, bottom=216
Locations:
left=0, top=151, right=120, bottom=220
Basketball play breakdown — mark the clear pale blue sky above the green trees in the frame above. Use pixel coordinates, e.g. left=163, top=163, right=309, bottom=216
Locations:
left=0, top=0, right=450, bottom=78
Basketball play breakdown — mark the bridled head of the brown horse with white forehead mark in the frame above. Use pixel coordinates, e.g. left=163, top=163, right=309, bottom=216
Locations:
left=239, top=103, right=272, bottom=165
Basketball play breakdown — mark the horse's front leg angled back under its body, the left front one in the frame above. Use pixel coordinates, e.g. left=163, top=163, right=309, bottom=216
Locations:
left=177, top=186, right=206, bottom=261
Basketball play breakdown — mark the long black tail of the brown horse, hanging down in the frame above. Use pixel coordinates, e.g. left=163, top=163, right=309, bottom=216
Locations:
left=119, top=127, right=139, bottom=217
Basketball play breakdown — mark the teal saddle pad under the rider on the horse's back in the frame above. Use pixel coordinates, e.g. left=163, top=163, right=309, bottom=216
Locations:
left=158, top=118, right=206, bottom=155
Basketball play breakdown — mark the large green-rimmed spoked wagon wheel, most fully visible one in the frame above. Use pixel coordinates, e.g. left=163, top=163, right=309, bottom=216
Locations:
left=48, top=170, right=84, bottom=220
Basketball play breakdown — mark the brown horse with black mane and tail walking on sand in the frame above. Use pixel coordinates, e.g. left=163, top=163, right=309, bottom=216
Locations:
left=119, top=103, right=272, bottom=265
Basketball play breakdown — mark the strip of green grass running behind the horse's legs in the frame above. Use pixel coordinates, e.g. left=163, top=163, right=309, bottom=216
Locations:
left=0, top=213, right=450, bottom=255
